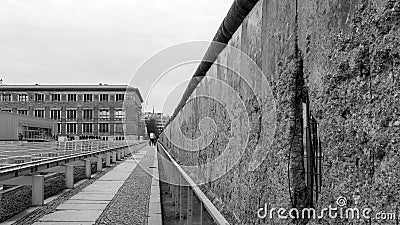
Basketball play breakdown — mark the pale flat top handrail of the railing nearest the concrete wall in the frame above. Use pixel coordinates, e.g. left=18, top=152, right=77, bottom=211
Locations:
left=158, top=142, right=229, bottom=225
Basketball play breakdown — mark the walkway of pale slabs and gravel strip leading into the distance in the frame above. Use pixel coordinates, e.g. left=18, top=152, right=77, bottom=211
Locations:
left=27, top=146, right=159, bottom=225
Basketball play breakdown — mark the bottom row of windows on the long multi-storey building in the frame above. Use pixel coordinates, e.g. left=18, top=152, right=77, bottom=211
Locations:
left=57, top=123, right=124, bottom=134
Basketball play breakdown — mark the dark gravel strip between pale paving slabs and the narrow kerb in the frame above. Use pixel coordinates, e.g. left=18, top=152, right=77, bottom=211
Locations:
left=96, top=150, right=154, bottom=225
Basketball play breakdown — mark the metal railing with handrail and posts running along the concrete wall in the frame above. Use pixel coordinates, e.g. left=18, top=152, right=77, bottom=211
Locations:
left=157, top=143, right=229, bottom=225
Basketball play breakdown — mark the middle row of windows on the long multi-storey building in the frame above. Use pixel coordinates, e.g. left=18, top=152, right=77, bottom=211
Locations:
left=2, top=109, right=126, bottom=120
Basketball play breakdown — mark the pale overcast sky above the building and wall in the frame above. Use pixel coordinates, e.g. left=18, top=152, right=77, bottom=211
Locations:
left=0, top=0, right=233, bottom=113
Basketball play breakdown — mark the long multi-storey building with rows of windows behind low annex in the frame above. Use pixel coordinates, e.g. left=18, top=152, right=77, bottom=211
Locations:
left=0, top=84, right=143, bottom=140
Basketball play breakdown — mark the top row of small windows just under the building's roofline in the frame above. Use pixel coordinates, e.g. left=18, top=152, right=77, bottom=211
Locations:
left=0, top=94, right=125, bottom=102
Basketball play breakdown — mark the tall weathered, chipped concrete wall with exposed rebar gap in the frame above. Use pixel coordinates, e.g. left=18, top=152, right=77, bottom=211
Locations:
left=161, top=0, right=400, bottom=224
